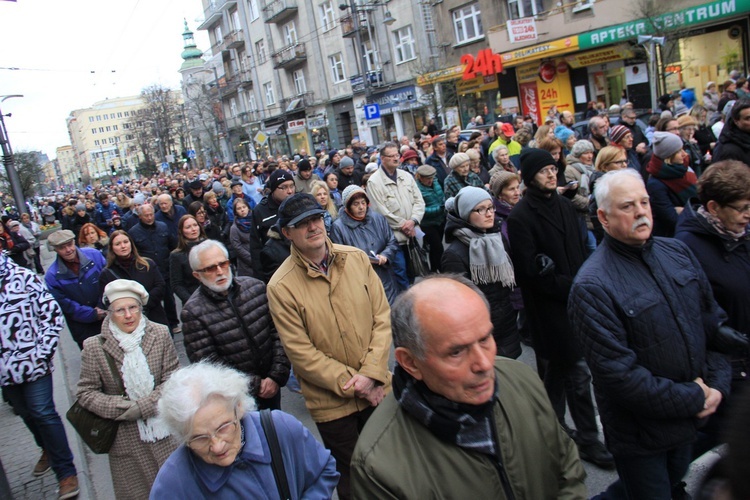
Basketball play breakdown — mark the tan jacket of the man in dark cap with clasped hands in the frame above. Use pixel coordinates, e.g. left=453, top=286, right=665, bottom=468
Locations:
left=267, top=241, right=394, bottom=422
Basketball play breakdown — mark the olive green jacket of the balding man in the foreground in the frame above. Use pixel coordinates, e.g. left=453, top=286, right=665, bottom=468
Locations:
left=351, top=358, right=587, bottom=500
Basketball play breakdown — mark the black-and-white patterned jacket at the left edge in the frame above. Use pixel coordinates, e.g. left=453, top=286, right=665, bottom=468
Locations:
left=0, top=255, right=63, bottom=386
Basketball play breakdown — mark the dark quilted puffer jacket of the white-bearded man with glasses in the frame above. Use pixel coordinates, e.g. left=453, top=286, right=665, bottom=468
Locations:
left=180, top=276, right=290, bottom=396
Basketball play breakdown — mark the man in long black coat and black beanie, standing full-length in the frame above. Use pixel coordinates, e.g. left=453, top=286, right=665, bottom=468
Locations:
left=508, top=148, right=614, bottom=468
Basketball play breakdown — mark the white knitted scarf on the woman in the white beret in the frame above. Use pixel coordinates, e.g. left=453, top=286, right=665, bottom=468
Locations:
left=109, top=316, right=169, bottom=443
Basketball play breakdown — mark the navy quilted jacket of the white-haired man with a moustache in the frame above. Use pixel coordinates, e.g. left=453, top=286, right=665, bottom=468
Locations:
left=568, top=236, right=731, bottom=457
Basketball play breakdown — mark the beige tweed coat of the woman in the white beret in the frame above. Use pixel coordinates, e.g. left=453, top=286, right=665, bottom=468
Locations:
left=77, top=318, right=179, bottom=500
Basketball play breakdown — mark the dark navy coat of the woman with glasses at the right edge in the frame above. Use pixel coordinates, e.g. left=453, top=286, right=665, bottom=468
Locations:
left=675, top=204, right=750, bottom=380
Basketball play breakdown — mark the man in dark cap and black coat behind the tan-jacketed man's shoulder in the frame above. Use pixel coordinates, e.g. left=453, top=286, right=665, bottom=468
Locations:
left=250, top=169, right=296, bottom=276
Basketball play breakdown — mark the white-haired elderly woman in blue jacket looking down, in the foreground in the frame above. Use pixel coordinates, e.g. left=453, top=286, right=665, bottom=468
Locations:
left=150, top=361, right=339, bottom=500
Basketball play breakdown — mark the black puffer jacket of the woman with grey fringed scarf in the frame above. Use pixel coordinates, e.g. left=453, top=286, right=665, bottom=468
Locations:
left=442, top=213, right=521, bottom=359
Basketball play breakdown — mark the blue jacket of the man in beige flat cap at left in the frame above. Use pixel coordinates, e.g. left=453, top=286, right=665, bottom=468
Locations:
left=44, top=248, right=106, bottom=346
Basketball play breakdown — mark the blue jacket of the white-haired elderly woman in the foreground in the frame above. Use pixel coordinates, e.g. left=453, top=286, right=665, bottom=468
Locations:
left=149, top=411, right=339, bottom=500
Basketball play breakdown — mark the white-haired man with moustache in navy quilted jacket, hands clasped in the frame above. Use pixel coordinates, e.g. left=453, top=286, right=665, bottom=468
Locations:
left=568, top=169, right=733, bottom=499
